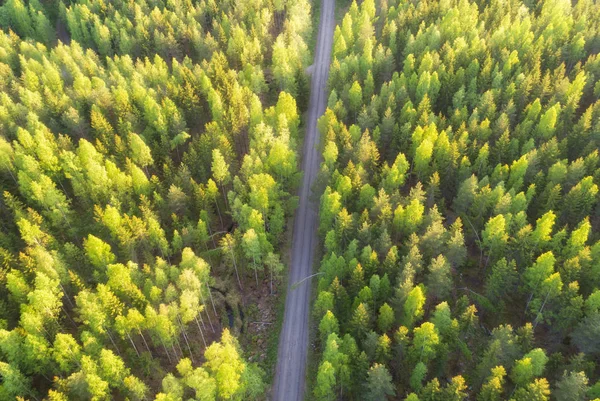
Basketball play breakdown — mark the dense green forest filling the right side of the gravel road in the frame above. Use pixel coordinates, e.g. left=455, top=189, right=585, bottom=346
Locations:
left=313, top=0, right=600, bottom=401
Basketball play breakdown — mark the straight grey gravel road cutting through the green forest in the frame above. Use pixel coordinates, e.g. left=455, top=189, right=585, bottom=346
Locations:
left=271, top=0, right=335, bottom=401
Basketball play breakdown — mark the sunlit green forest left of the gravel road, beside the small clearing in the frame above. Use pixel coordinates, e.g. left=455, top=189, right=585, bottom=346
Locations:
left=0, top=0, right=311, bottom=401
